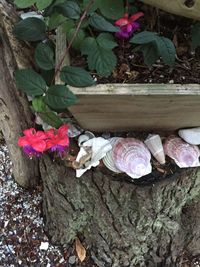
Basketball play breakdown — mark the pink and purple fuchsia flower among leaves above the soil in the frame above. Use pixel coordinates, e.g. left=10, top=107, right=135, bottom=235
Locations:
left=115, top=12, right=144, bottom=39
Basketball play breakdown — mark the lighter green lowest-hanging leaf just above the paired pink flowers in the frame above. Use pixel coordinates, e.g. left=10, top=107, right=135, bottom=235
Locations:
left=32, top=97, right=62, bottom=128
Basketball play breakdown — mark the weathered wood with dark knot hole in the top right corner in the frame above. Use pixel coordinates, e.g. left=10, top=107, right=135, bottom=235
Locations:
left=142, top=0, right=200, bottom=20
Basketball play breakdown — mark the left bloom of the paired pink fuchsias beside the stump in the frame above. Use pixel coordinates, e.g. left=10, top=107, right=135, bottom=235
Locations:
left=18, top=128, right=46, bottom=156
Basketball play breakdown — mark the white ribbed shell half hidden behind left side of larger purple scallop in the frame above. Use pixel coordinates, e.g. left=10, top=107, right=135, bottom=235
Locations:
left=103, top=137, right=122, bottom=173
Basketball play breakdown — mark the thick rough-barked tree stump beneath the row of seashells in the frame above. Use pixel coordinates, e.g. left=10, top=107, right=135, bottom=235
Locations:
left=40, top=157, right=200, bottom=267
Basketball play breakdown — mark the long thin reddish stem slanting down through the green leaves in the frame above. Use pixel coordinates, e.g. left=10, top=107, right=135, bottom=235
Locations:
left=52, top=0, right=94, bottom=83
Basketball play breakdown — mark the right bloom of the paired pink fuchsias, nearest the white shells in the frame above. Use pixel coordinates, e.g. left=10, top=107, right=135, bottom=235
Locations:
left=46, top=125, right=69, bottom=154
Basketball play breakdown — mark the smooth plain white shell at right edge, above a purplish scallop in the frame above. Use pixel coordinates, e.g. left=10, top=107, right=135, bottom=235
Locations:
left=178, top=127, right=200, bottom=145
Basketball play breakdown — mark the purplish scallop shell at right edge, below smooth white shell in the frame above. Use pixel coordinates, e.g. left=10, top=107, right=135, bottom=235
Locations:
left=164, top=136, right=200, bottom=168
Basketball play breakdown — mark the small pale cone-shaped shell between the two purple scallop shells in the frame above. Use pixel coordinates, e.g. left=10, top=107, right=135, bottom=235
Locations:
left=144, top=134, right=165, bottom=164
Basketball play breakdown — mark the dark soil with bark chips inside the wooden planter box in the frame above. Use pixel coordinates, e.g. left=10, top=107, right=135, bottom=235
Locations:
left=71, top=3, right=200, bottom=84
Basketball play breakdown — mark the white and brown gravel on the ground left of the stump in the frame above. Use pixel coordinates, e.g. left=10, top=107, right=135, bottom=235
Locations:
left=0, top=144, right=76, bottom=267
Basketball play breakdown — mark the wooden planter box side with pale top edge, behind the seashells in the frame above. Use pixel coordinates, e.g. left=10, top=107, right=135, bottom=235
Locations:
left=70, top=84, right=200, bottom=132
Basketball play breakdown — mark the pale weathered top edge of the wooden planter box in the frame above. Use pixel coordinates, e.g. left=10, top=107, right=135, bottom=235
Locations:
left=69, top=83, right=200, bottom=95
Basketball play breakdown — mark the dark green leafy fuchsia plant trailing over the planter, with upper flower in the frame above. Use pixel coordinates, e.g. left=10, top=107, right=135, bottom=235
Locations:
left=13, top=0, right=179, bottom=130
